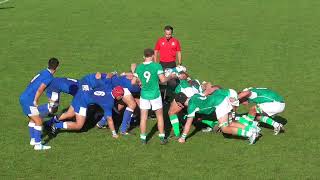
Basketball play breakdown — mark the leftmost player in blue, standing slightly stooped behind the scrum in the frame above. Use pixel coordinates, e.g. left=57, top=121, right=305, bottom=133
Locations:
left=20, top=58, right=59, bottom=150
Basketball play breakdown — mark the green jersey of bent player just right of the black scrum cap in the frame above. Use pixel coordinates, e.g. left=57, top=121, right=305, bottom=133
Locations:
left=188, top=94, right=227, bottom=118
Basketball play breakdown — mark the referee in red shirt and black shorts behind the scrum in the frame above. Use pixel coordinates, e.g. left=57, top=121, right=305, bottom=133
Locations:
left=154, top=25, right=182, bottom=102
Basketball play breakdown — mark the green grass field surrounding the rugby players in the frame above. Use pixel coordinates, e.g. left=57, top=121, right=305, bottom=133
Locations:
left=0, top=0, right=320, bottom=179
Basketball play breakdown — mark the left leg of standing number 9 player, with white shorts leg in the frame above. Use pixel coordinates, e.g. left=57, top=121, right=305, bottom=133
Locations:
left=140, top=98, right=151, bottom=144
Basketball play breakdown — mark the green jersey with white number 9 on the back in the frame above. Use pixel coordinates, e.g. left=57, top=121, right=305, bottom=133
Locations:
left=134, top=62, right=163, bottom=100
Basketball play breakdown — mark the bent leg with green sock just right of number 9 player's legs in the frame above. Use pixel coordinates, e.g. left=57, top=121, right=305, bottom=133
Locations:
left=168, top=100, right=182, bottom=137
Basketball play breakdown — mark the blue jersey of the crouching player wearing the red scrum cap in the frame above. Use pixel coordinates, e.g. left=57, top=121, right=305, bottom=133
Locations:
left=72, top=87, right=114, bottom=118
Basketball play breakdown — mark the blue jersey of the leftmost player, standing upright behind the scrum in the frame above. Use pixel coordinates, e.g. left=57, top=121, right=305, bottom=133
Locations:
left=20, top=69, right=54, bottom=102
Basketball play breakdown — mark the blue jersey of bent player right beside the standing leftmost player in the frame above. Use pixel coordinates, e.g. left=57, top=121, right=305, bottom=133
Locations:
left=47, top=78, right=79, bottom=97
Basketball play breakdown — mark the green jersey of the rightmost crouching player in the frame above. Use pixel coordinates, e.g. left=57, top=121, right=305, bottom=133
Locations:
left=248, top=88, right=284, bottom=104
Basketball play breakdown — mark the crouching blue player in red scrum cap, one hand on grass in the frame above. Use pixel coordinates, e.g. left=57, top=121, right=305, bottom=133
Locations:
left=51, top=86, right=124, bottom=138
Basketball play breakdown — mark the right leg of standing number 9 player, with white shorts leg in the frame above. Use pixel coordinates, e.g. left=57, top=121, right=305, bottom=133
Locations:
left=150, top=96, right=167, bottom=144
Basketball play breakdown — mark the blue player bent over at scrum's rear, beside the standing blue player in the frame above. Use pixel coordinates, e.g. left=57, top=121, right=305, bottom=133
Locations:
left=38, top=78, right=79, bottom=118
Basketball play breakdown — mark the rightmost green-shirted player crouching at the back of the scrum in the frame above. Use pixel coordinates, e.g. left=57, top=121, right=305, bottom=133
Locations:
left=239, top=87, right=285, bottom=135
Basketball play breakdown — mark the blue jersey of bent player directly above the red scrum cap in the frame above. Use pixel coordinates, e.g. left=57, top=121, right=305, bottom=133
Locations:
left=111, top=75, right=141, bottom=93
